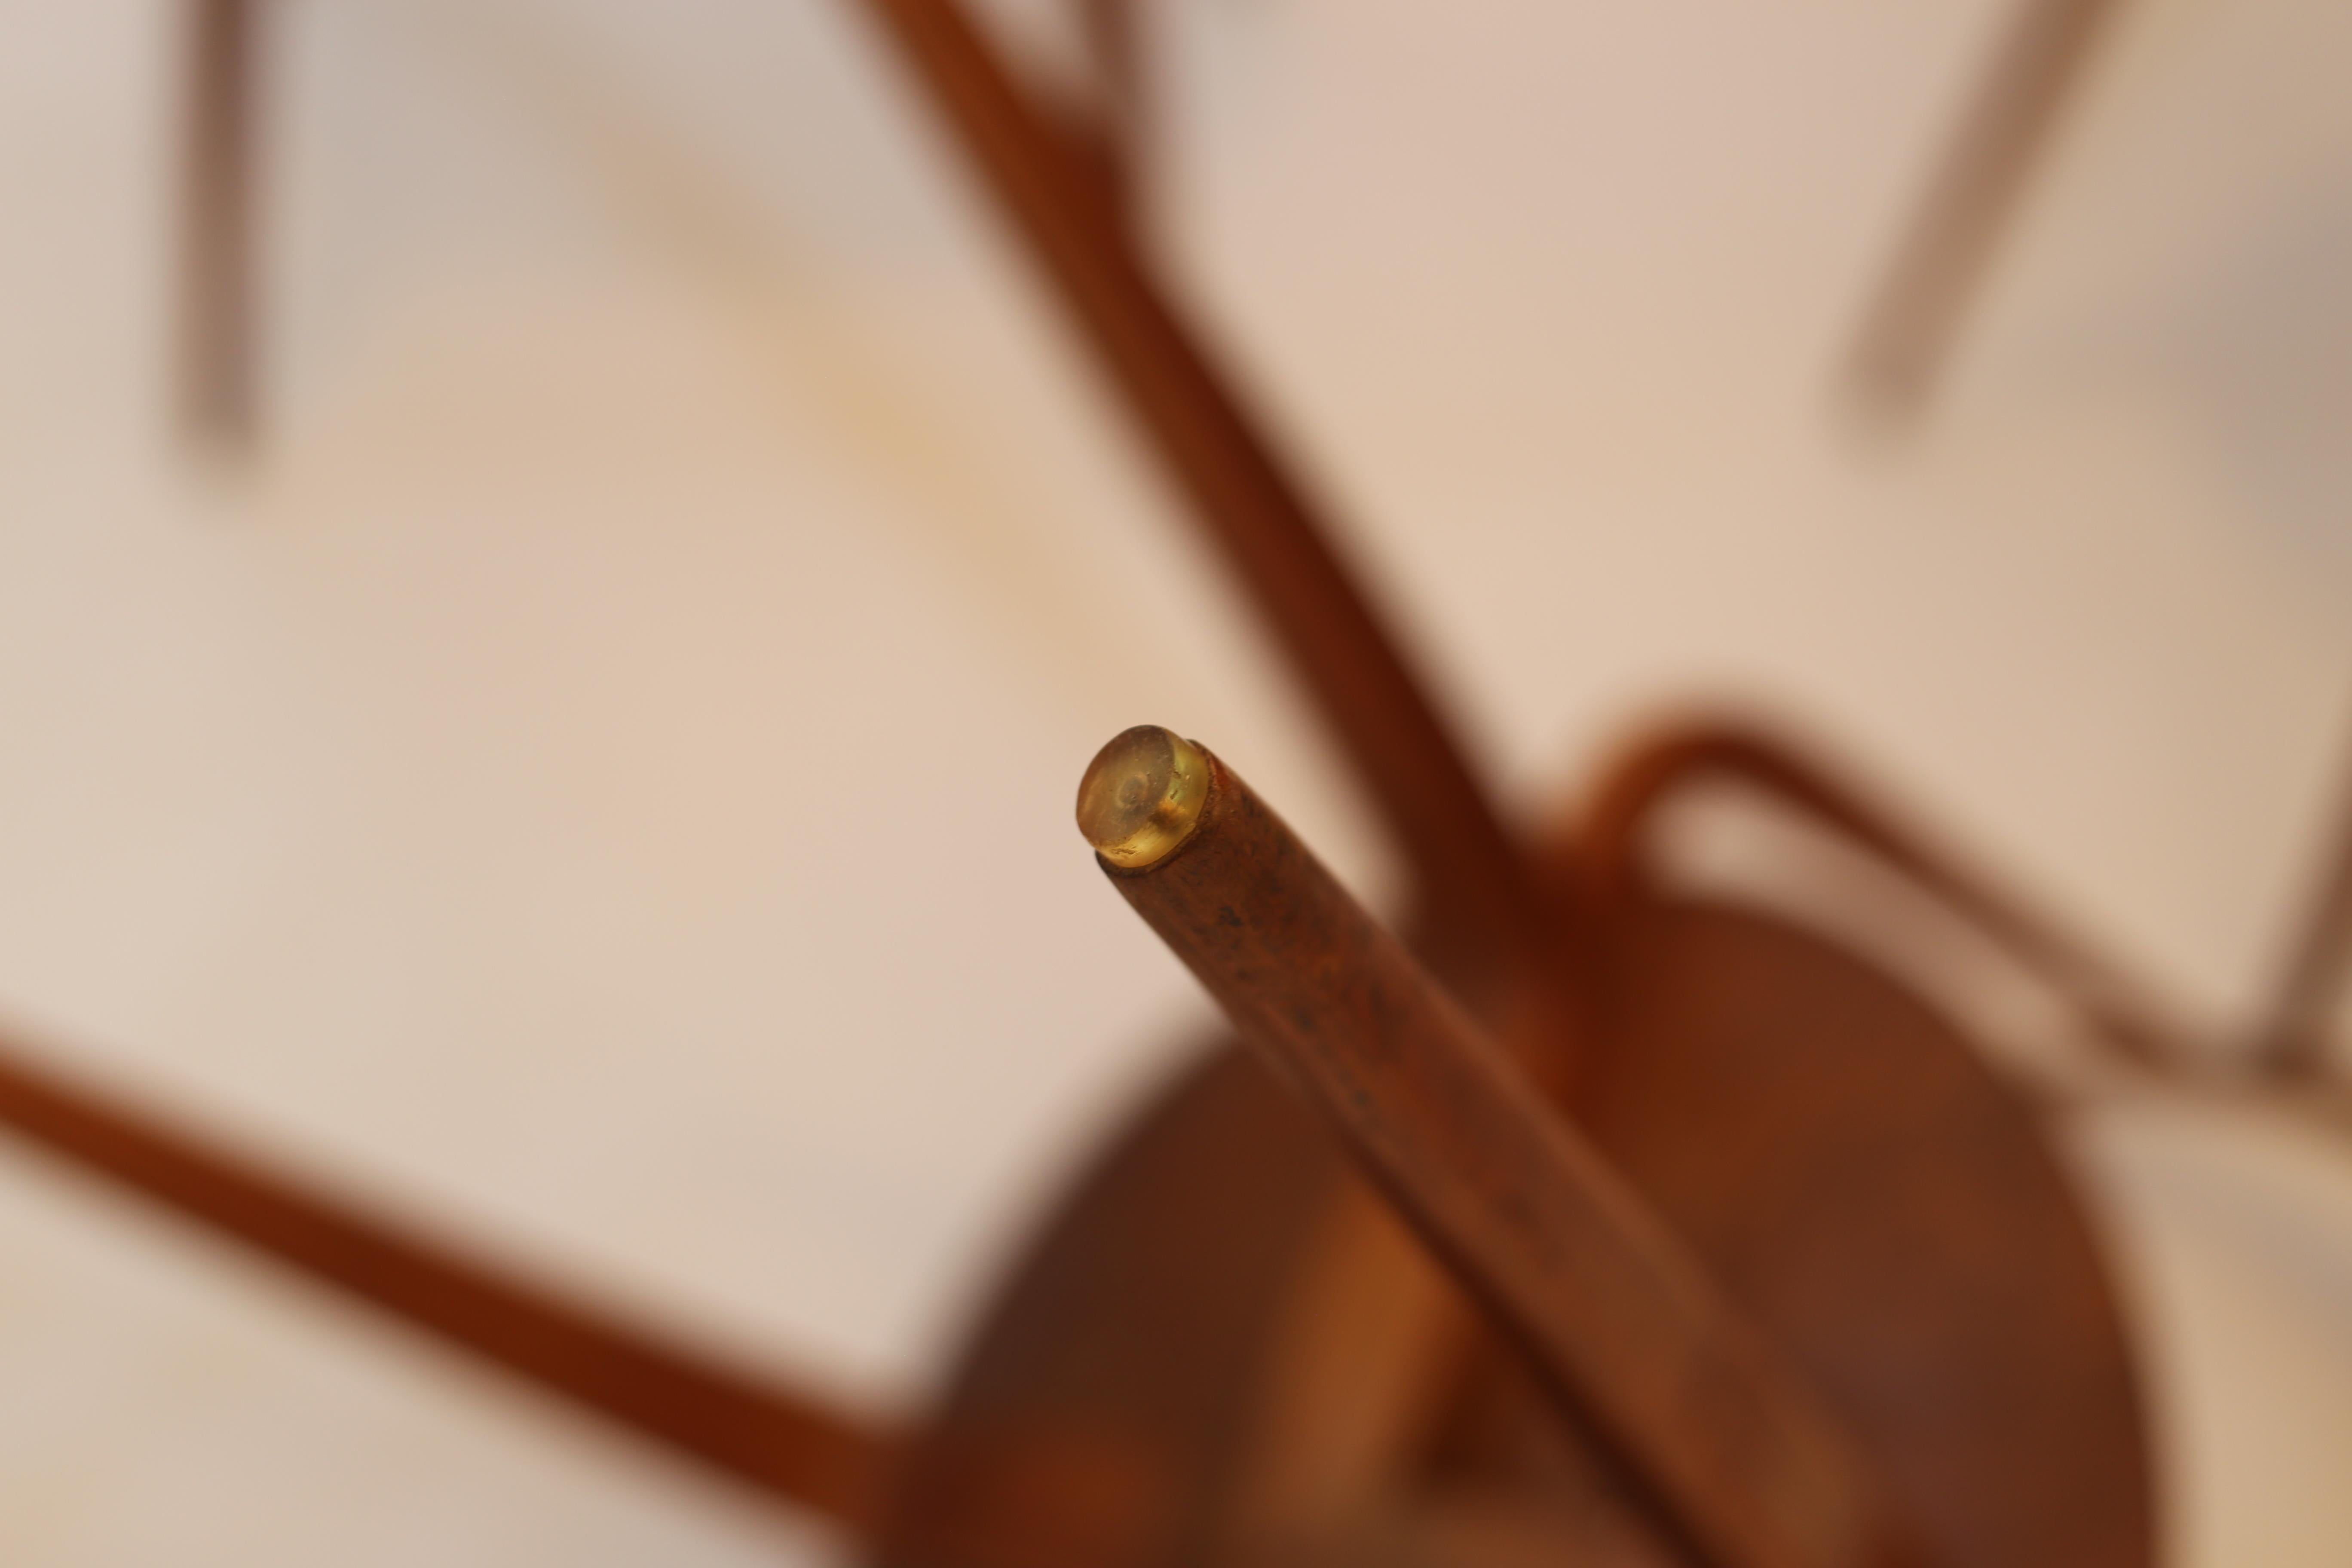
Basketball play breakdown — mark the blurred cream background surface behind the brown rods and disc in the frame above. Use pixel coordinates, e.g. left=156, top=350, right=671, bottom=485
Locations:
left=0, top=0, right=2352, bottom=1568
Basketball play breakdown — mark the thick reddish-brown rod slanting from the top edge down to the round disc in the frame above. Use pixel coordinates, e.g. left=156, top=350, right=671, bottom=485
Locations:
left=861, top=0, right=1543, bottom=955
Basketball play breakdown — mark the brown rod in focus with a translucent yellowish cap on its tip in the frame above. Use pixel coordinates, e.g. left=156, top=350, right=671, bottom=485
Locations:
left=1077, top=726, right=1917, bottom=1568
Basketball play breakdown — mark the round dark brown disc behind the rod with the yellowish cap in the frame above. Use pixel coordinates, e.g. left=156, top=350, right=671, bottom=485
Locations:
left=873, top=900, right=2152, bottom=1568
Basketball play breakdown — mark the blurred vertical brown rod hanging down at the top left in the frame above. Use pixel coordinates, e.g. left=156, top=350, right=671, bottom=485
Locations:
left=179, top=0, right=263, bottom=449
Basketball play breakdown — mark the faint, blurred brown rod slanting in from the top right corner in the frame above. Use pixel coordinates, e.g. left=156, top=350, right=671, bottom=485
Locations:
left=1849, top=0, right=2122, bottom=419
